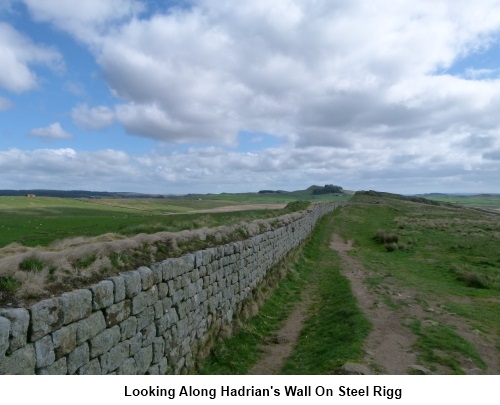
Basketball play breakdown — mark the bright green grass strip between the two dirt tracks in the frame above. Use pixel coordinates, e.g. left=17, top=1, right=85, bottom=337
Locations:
left=283, top=215, right=370, bottom=374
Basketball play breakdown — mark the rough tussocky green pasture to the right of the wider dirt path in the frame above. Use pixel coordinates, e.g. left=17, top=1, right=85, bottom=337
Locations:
left=334, top=195, right=500, bottom=373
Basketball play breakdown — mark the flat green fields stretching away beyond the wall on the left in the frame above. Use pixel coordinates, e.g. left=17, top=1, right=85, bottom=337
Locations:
left=0, top=193, right=347, bottom=248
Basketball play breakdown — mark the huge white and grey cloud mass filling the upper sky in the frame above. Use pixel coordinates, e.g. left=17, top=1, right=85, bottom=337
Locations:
left=18, top=0, right=500, bottom=146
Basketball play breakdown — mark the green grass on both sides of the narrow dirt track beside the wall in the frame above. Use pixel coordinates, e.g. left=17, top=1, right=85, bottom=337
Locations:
left=199, top=214, right=369, bottom=374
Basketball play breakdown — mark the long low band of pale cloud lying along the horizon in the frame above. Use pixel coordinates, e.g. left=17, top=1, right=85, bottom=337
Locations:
left=0, top=138, right=500, bottom=194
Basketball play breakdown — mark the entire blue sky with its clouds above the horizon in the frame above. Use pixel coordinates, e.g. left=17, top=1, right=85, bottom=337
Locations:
left=0, top=0, right=500, bottom=194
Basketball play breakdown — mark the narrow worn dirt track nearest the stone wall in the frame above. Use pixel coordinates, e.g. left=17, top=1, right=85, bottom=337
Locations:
left=248, top=288, right=312, bottom=375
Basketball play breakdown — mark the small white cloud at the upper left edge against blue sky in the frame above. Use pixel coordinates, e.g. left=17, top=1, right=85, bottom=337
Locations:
left=0, top=22, right=64, bottom=92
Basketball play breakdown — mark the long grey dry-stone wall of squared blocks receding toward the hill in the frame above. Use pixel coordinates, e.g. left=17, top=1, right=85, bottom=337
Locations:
left=0, top=204, right=335, bottom=374
